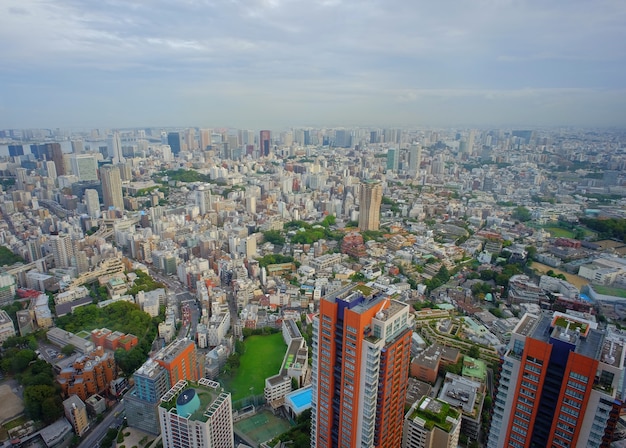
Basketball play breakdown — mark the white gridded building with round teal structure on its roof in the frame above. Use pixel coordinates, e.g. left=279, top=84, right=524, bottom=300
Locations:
left=158, top=378, right=235, bottom=448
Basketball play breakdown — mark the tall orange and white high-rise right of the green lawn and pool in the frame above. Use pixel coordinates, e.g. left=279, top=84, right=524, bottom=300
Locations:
left=311, top=286, right=412, bottom=448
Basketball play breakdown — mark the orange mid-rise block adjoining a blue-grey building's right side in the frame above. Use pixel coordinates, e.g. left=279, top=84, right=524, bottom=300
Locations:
left=154, top=338, right=201, bottom=386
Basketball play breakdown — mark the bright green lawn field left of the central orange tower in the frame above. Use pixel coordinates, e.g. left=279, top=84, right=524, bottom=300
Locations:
left=223, top=333, right=287, bottom=402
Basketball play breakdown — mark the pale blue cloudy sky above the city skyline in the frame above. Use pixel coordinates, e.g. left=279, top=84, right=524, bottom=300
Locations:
left=0, top=0, right=626, bottom=129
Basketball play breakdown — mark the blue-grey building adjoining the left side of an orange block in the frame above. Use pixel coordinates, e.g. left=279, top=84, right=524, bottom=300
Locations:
left=125, top=359, right=171, bottom=435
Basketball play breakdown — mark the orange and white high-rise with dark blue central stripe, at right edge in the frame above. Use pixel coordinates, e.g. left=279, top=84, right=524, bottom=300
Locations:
left=487, top=312, right=626, bottom=448
